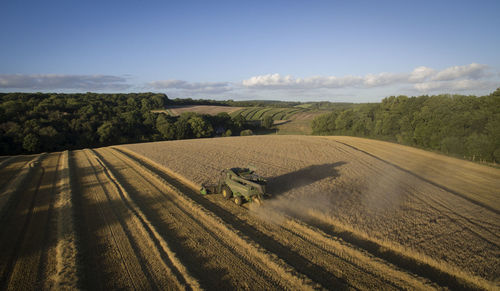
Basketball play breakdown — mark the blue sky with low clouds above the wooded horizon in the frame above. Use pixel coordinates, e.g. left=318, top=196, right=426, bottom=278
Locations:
left=0, top=0, right=500, bottom=102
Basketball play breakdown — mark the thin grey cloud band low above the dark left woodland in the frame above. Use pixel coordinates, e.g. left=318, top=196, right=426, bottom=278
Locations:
left=0, top=74, right=131, bottom=91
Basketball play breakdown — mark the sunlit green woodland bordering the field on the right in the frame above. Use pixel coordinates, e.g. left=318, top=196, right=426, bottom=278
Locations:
left=312, top=88, right=500, bottom=163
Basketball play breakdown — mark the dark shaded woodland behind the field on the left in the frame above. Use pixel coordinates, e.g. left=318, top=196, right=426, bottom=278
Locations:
left=0, top=93, right=248, bottom=155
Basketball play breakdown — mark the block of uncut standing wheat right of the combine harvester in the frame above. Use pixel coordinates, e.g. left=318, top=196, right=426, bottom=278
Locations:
left=127, top=136, right=500, bottom=288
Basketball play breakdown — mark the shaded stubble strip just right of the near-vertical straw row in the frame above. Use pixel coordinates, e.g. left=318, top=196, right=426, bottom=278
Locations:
left=75, top=150, right=153, bottom=290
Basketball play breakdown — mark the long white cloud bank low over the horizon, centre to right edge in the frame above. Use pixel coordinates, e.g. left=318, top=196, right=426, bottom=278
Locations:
left=146, top=63, right=499, bottom=100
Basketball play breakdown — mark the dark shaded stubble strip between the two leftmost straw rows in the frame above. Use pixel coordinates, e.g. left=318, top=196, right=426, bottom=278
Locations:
left=0, top=153, right=61, bottom=290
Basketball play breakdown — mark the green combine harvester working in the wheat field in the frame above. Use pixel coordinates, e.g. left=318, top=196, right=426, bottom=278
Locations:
left=200, top=167, right=267, bottom=205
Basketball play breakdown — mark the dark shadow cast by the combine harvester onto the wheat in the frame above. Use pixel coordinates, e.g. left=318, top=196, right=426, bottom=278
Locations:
left=267, top=161, right=346, bottom=196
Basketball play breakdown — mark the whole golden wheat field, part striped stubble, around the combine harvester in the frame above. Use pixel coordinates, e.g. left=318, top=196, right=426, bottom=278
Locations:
left=0, top=136, right=500, bottom=290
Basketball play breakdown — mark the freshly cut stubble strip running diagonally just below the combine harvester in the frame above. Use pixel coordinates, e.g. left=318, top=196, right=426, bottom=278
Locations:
left=113, top=149, right=430, bottom=290
